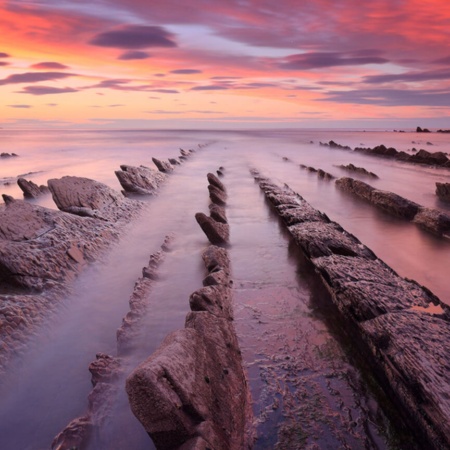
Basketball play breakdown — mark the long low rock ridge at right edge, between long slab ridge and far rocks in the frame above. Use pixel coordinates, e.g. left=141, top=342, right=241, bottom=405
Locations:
left=336, top=177, right=450, bottom=237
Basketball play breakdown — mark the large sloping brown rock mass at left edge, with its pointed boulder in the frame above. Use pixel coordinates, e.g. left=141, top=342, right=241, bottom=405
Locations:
left=0, top=177, right=142, bottom=370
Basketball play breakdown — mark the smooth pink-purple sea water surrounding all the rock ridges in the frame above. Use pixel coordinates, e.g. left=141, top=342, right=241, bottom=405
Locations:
left=0, top=129, right=450, bottom=450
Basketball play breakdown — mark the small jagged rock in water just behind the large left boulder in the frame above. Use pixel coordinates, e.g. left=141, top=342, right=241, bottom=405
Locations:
left=115, top=165, right=166, bottom=195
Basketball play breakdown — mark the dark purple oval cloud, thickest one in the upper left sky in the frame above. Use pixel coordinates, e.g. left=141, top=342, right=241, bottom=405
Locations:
left=89, top=25, right=177, bottom=50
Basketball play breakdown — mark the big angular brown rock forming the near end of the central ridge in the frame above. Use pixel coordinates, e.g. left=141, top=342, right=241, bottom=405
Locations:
left=126, top=246, right=250, bottom=450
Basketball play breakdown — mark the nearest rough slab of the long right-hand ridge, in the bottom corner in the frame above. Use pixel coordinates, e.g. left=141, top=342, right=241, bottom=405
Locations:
left=362, top=312, right=450, bottom=449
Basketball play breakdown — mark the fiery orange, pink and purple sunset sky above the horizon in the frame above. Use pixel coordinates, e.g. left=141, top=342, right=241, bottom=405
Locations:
left=0, top=0, right=450, bottom=129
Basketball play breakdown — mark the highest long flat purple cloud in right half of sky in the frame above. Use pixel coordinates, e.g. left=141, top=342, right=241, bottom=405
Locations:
left=280, top=50, right=389, bottom=70
